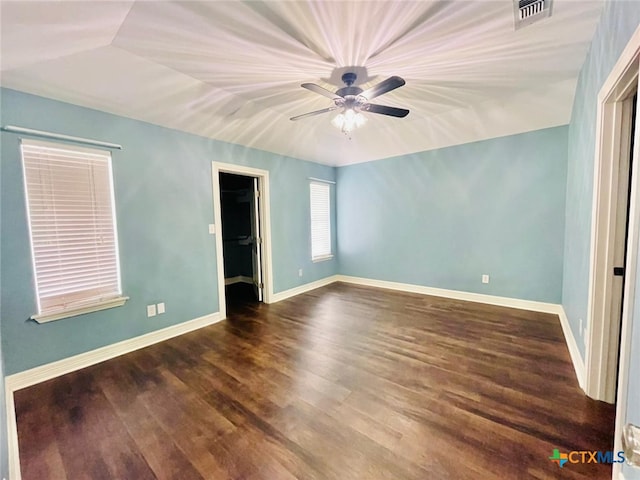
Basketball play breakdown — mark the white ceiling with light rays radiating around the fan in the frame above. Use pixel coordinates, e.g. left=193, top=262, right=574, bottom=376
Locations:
left=0, top=0, right=602, bottom=165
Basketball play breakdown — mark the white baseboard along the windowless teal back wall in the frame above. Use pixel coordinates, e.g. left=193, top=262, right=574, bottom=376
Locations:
left=336, top=275, right=560, bottom=315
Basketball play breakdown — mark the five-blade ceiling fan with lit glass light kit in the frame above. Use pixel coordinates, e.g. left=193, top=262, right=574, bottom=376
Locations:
left=291, top=72, right=409, bottom=134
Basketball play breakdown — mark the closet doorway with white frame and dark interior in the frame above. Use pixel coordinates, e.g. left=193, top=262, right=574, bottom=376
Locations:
left=213, top=162, right=272, bottom=316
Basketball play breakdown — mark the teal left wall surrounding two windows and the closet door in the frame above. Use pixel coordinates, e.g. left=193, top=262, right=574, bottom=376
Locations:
left=0, top=89, right=337, bottom=375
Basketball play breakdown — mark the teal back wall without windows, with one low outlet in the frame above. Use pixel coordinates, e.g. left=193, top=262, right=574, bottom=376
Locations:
left=337, top=127, right=567, bottom=303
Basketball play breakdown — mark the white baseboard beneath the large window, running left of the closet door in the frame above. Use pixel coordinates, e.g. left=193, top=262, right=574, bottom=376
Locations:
left=4, top=312, right=224, bottom=480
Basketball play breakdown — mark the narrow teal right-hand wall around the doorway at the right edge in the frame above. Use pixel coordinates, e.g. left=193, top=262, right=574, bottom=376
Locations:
left=562, top=0, right=640, bottom=480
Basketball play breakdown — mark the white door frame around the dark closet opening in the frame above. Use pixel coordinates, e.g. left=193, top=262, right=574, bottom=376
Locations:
left=211, top=161, right=273, bottom=318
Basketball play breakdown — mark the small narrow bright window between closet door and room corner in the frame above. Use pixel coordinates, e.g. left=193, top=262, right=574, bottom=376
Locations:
left=309, top=182, right=333, bottom=262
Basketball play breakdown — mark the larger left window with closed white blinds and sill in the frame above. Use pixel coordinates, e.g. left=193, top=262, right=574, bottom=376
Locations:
left=22, top=140, right=127, bottom=322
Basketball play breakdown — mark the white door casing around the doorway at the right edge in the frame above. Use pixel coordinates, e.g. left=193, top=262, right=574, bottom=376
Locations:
left=585, top=21, right=640, bottom=479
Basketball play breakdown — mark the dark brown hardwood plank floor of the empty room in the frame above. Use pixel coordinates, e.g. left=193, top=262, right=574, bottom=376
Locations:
left=15, top=283, right=614, bottom=480
